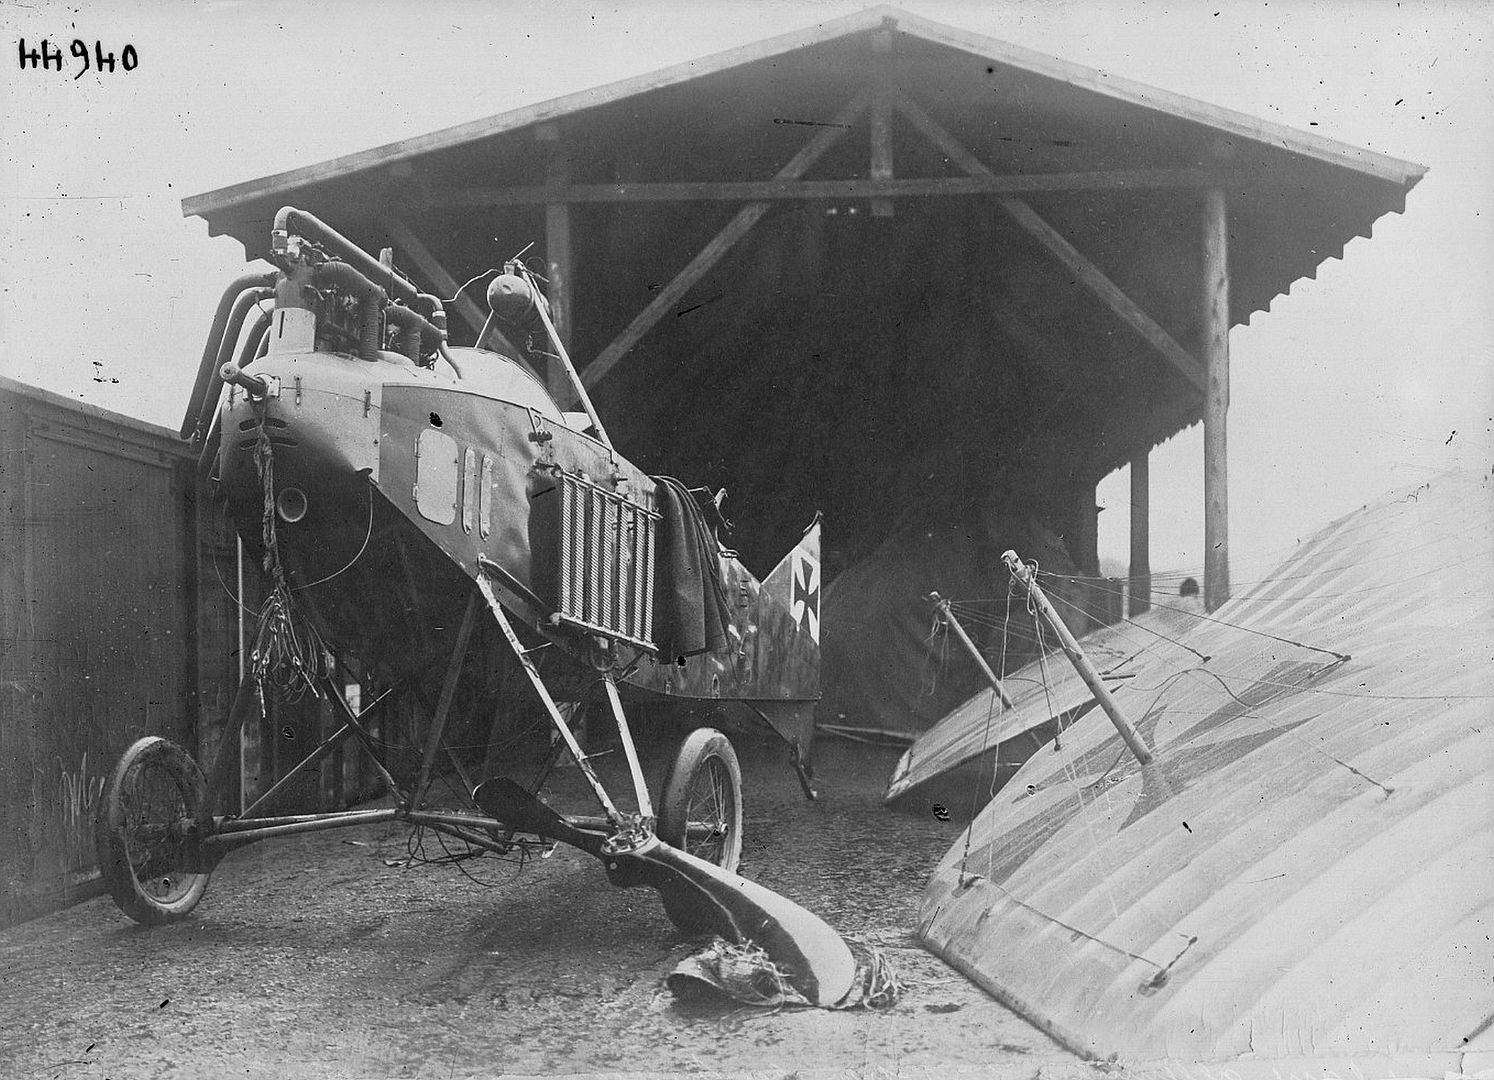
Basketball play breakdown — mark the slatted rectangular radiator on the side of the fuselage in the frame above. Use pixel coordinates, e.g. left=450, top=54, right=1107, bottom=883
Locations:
left=557, top=474, right=659, bottom=650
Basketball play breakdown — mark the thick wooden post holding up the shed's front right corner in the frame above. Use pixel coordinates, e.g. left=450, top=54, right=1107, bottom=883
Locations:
left=1201, top=188, right=1230, bottom=611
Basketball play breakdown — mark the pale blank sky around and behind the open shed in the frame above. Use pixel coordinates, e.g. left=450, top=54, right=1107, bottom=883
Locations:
left=0, top=0, right=1494, bottom=583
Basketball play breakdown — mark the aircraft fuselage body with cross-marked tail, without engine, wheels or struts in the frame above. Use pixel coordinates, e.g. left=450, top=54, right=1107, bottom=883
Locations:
left=220, top=342, right=819, bottom=734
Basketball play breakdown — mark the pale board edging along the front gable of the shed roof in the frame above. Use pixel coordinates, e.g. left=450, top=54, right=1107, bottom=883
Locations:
left=182, top=4, right=1427, bottom=217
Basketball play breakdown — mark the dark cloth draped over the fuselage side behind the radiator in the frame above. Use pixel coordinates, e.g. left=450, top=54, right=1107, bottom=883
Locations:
left=653, top=477, right=731, bottom=659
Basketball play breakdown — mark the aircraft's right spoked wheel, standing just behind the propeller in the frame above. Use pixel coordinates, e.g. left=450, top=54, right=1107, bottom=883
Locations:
left=657, top=727, right=743, bottom=934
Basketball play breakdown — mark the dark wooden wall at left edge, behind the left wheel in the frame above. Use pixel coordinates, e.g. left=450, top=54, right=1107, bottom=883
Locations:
left=0, top=385, right=199, bottom=922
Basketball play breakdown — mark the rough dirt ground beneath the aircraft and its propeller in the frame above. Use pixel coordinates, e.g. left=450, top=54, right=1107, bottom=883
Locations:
left=0, top=742, right=1086, bottom=1080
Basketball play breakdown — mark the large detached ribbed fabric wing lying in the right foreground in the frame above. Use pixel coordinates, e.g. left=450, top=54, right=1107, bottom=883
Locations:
left=920, top=475, right=1494, bottom=1076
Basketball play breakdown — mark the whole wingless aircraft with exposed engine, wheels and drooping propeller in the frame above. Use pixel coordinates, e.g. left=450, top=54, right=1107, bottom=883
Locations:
left=96, top=206, right=856, bottom=1004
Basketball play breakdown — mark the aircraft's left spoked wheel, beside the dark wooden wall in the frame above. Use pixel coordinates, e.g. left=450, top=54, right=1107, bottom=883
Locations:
left=94, top=735, right=208, bottom=926
